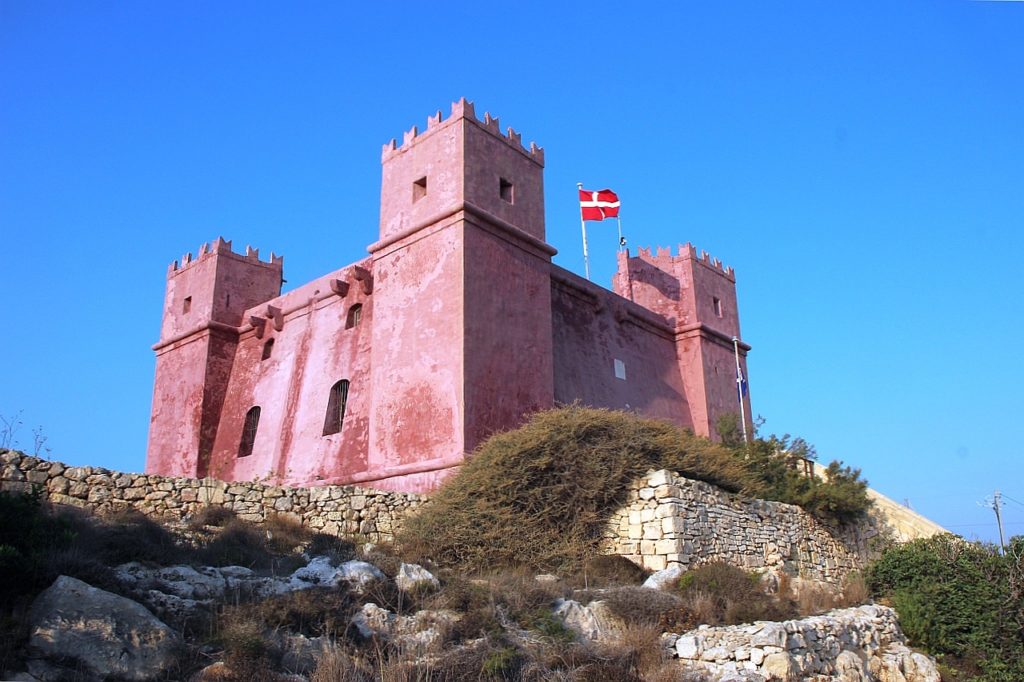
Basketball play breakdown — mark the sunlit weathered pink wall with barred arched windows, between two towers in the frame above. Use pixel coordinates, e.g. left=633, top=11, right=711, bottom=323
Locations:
left=210, top=260, right=373, bottom=484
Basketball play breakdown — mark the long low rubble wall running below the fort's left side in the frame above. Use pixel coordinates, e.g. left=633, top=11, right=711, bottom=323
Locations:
left=0, top=451, right=425, bottom=542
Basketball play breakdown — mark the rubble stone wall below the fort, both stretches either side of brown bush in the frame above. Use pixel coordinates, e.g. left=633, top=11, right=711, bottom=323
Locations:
left=0, top=451, right=877, bottom=584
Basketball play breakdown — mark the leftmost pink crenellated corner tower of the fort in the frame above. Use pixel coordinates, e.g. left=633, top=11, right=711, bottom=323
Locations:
left=145, top=238, right=284, bottom=476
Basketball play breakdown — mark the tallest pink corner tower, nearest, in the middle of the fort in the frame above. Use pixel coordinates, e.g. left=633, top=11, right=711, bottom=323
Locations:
left=370, top=99, right=555, bottom=488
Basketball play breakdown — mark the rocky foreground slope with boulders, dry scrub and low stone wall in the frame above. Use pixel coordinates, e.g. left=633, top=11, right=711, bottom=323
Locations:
left=5, top=546, right=939, bottom=682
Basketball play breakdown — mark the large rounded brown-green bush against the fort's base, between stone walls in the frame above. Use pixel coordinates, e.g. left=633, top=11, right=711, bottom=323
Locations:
left=399, top=404, right=758, bottom=572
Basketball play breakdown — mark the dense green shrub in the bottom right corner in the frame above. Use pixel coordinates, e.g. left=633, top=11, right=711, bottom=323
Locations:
left=866, top=535, right=1024, bottom=682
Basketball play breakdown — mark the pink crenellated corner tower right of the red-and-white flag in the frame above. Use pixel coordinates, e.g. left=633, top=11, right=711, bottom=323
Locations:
left=613, top=244, right=752, bottom=437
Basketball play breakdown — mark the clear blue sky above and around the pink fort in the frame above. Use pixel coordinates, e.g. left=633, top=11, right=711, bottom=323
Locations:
left=0, top=0, right=1024, bottom=540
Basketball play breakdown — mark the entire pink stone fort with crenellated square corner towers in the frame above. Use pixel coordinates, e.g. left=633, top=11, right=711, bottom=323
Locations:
left=145, top=99, right=750, bottom=492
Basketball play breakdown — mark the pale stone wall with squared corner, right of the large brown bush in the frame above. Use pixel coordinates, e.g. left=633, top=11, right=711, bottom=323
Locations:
left=605, top=471, right=879, bottom=585
